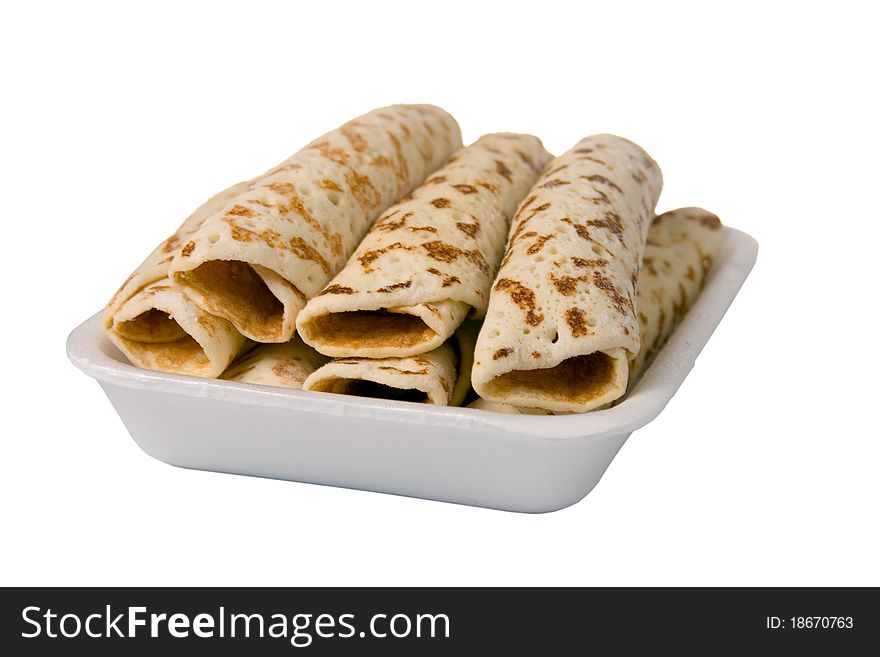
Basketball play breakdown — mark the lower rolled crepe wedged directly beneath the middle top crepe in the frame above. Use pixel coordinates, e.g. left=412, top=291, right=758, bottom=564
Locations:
left=303, top=322, right=478, bottom=406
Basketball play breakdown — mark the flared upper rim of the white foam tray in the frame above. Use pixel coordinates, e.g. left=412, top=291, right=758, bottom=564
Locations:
left=67, top=227, right=758, bottom=441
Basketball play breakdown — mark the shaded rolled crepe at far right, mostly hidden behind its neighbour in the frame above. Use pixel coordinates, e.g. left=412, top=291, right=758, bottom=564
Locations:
left=629, top=208, right=722, bottom=380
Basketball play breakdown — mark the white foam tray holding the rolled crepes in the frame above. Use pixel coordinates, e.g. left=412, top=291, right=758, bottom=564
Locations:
left=67, top=228, right=758, bottom=513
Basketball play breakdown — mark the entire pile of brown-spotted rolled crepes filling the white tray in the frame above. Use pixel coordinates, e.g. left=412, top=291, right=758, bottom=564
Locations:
left=105, top=105, right=721, bottom=414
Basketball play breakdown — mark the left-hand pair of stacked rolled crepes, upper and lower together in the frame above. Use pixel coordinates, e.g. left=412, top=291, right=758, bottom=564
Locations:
left=105, top=105, right=461, bottom=377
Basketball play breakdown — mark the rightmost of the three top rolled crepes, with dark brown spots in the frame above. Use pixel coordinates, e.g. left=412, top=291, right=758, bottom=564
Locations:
left=472, top=135, right=662, bottom=412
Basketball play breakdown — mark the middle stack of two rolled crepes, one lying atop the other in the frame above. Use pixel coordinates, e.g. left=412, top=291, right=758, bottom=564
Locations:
left=296, top=133, right=550, bottom=405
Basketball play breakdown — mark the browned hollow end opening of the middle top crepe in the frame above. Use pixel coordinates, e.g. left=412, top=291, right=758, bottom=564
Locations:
left=304, top=310, right=437, bottom=349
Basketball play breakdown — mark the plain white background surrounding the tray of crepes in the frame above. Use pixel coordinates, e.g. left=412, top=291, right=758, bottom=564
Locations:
left=0, top=0, right=880, bottom=584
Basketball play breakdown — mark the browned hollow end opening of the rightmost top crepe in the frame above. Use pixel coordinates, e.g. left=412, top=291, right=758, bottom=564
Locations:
left=487, top=351, right=614, bottom=403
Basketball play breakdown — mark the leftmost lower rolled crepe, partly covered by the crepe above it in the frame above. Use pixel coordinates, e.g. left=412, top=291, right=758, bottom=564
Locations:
left=104, top=181, right=251, bottom=377
